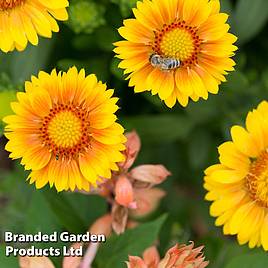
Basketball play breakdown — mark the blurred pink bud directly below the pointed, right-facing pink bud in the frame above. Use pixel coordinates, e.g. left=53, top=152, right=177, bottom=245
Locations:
left=131, top=188, right=165, bottom=217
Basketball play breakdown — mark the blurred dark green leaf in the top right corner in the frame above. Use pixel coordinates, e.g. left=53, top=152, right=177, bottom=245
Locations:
left=233, top=0, right=268, bottom=44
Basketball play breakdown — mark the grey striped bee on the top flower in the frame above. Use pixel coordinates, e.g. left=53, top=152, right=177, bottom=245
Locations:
left=149, top=53, right=181, bottom=71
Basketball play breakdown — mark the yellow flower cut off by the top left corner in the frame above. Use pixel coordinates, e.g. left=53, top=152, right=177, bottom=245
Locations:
left=0, top=0, right=69, bottom=52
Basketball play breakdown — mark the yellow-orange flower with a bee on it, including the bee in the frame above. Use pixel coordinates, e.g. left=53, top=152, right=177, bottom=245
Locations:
left=114, top=0, right=237, bottom=108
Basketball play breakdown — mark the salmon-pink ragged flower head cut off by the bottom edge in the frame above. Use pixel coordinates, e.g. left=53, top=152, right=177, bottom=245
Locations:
left=127, top=242, right=209, bottom=268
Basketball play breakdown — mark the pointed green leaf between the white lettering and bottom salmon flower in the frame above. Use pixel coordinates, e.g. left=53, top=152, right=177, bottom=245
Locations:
left=96, top=215, right=166, bottom=268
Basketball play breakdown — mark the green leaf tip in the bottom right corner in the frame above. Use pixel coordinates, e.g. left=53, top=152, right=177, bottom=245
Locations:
left=225, top=252, right=268, bottom=268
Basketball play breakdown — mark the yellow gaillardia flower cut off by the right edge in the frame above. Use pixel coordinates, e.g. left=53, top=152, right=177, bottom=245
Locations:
left=204, top=101, right=268, bottom=250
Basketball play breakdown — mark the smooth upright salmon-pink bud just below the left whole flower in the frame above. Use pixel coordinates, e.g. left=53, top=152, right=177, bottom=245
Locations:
left=115, top=175, right=135, bottom=208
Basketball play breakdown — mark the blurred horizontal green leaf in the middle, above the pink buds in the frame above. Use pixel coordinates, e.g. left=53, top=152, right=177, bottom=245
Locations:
left=123, top=114, right=193, bottom=143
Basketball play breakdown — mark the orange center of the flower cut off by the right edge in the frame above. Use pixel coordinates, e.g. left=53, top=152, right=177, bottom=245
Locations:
left=246, top=151, right=268, bottom=208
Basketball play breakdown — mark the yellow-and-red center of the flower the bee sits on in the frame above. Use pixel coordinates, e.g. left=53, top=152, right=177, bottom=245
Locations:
left=152, top=21, right=201, bottom=66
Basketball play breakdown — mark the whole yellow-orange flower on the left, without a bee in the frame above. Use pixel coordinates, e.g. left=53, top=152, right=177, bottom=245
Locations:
left=3, top=67, right=126, bottom=191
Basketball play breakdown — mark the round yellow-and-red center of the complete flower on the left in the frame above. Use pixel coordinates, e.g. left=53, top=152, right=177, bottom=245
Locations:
left=40, top=104, right=91, bottom=159
